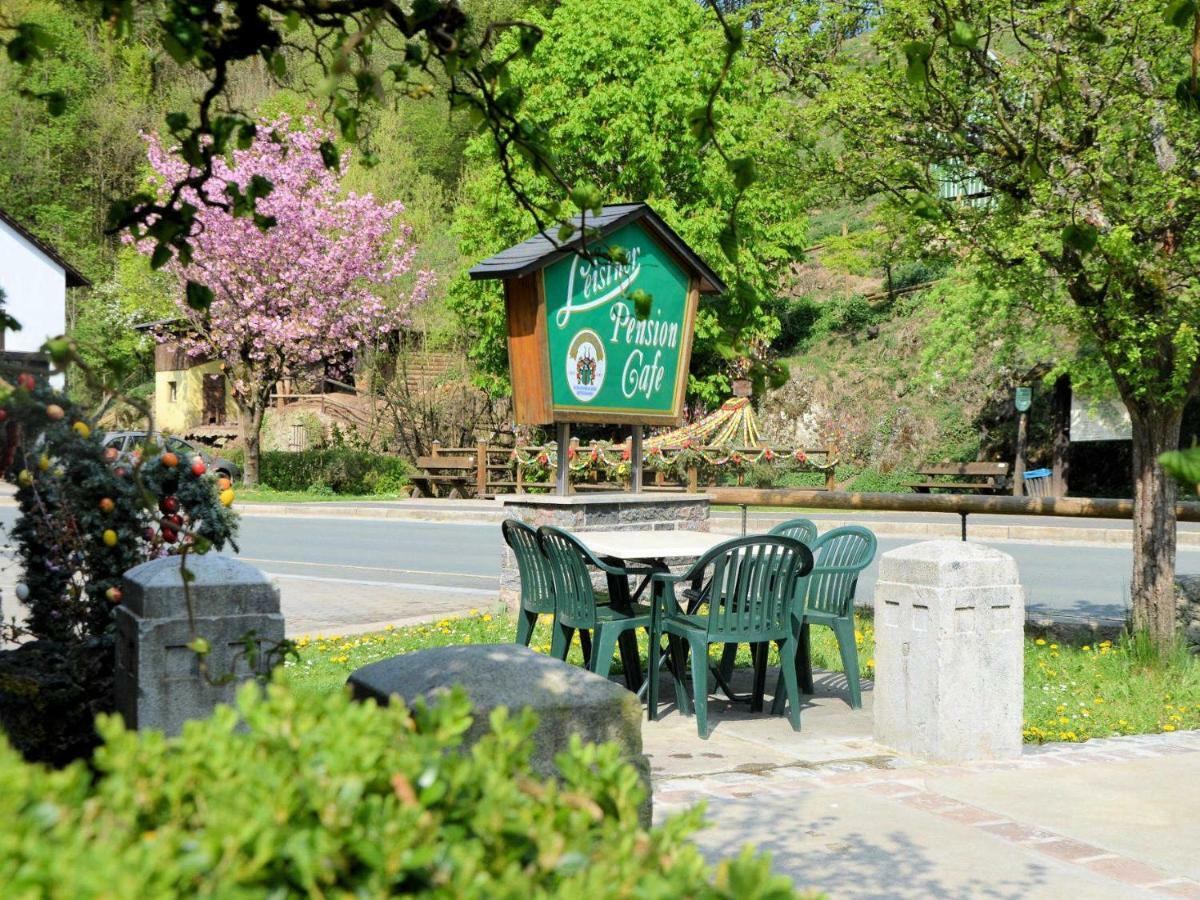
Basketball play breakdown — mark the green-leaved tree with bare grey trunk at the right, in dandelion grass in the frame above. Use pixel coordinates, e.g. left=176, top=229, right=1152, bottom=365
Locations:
left=806, top=0, right=1200, bottom=647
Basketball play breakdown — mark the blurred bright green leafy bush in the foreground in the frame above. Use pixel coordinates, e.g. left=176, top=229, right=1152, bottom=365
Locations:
left=0, top=684, right=793, bottom=898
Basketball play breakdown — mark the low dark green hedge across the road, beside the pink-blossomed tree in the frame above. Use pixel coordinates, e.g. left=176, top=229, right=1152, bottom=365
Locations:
left=259, top=446, right=408, bottom=494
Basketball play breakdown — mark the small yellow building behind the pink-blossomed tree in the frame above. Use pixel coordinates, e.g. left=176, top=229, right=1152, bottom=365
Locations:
left=154, top=341, right=238, bottom=434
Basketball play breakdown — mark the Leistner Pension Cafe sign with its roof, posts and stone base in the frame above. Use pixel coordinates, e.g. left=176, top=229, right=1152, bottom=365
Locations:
left=470, top=203, right=726, bottom=604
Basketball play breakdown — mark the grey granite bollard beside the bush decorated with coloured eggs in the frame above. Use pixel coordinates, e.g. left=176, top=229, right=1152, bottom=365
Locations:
left=115, top=553, right=283, bottom=734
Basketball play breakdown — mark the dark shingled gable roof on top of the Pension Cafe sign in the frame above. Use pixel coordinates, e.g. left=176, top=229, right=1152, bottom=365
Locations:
left=470, top=203, right=726, bottom=294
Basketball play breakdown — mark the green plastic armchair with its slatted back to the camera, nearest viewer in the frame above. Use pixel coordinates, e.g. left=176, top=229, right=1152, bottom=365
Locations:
left=648, top=535, right=812, bottom=738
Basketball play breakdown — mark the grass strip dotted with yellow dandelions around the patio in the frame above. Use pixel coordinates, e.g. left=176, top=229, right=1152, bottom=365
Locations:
left=286, top=611, right=1200, bottom=743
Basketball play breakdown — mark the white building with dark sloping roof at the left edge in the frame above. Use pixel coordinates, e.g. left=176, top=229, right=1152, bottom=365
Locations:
left=0, top=209, right=91, bottom=367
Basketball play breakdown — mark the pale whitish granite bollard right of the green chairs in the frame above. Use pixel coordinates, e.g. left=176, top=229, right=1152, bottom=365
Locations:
left=875, top=540, right=1025, bottom=762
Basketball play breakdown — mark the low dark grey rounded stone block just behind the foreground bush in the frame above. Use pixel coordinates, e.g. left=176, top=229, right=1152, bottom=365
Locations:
left=347, top=644, right=650, bottom=824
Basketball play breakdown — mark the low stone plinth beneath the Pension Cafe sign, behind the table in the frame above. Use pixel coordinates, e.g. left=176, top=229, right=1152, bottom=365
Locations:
left=500, top=492, right=709, bottom=611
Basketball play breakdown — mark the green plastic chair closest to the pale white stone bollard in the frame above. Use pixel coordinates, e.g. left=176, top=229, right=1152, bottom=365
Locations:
left=772, top=526, right=878, bottom=714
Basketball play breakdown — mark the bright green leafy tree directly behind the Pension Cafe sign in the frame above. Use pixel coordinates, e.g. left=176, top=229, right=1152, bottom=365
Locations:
left=451, top=0, right=805, bottom=403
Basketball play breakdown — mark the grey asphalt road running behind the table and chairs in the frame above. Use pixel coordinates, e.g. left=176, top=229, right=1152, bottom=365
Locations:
left=9, top=509, right=1200, bottom=618
